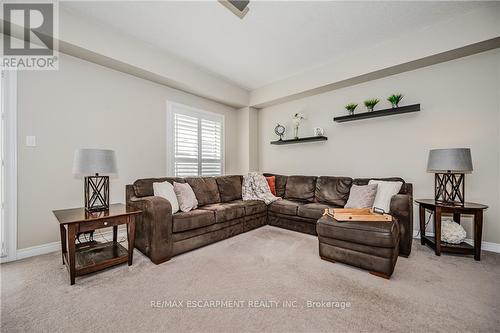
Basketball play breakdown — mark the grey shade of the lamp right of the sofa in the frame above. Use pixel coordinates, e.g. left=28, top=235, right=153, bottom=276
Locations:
left=427, top=148, right=472, bottom=173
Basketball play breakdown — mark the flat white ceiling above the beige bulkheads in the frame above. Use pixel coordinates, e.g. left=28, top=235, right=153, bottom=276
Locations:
left=63, top=1, right=484, bottom=90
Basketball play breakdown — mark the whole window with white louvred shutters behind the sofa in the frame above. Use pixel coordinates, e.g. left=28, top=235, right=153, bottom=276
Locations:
left=167, top=103, right=224, bottom=177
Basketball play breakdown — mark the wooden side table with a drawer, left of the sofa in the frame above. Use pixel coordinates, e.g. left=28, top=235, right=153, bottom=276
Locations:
left=53, top=204, right=142, bottom=285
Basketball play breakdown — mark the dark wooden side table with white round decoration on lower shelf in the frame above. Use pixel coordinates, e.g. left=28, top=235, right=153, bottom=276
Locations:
left=415, top=199, right=488, bottom=260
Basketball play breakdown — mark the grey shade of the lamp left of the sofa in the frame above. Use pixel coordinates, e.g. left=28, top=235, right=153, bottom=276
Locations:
left=73, top=149, right=118, bottom=175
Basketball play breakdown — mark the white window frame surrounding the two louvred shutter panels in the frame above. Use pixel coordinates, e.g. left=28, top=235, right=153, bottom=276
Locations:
left=166, top=101, right=226, bottom=177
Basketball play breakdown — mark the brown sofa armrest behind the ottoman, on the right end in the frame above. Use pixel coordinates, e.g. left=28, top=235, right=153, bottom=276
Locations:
left=391, top=194, right=413, bottom=257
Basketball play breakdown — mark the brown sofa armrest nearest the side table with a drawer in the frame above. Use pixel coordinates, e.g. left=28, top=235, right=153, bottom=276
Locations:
left=127, top=196, right=172, bottom=264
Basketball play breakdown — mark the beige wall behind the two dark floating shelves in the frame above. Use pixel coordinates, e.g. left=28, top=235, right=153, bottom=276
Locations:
left=259, top=50, right=500, bottom=243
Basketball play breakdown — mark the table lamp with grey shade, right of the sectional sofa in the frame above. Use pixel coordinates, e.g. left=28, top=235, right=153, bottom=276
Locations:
left=427, top=148, right=472, bottom=206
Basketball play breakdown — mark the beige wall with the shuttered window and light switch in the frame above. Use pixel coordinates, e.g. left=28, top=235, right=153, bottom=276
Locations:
left=17, top=54, right=239, bottom=249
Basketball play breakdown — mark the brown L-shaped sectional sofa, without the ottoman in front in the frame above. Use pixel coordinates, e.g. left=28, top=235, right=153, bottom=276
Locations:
left=126, top=174, right=413, bottom=264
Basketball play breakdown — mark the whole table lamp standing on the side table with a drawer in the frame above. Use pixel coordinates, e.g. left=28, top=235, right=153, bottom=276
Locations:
left=73, top=149, right=117, bottom=212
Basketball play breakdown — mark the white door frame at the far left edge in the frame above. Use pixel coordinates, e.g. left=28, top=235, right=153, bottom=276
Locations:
left=0, top=67, right=17, bottom=262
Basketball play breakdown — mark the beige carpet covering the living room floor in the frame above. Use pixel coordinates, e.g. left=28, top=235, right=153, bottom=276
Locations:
left=1, top=226, right=500, bottom=332
